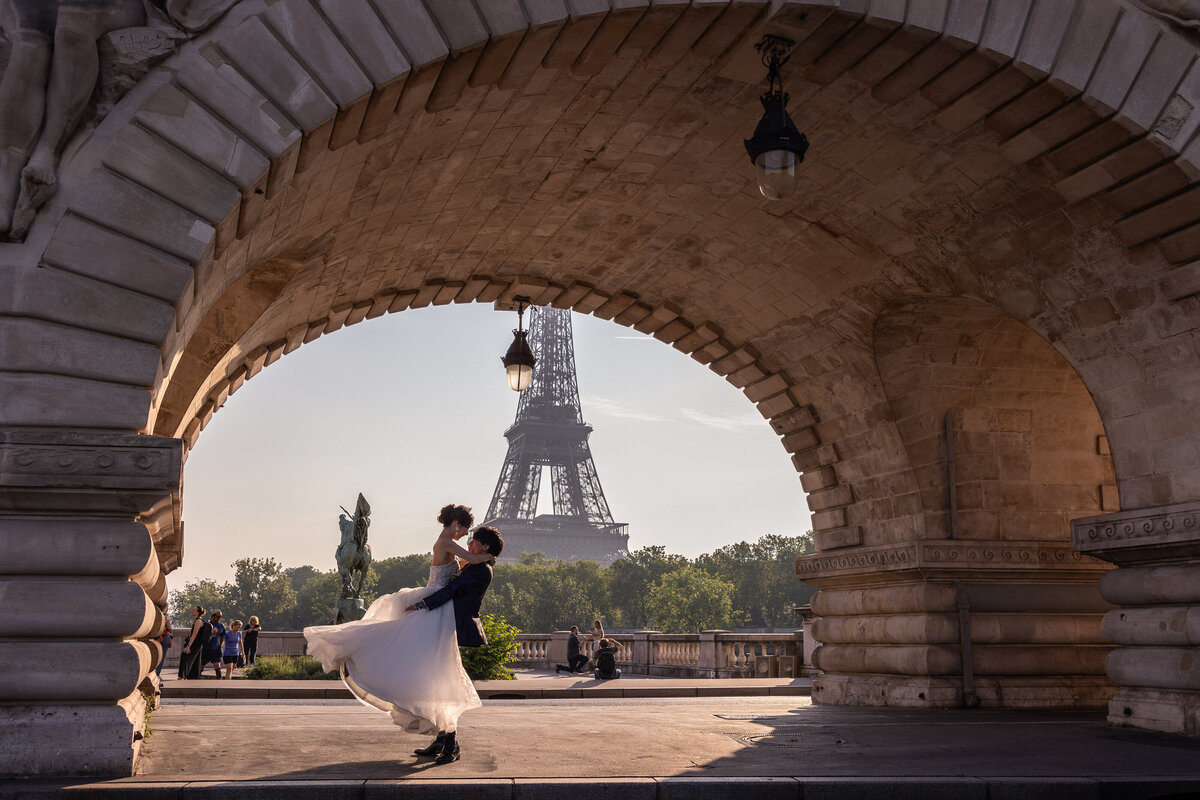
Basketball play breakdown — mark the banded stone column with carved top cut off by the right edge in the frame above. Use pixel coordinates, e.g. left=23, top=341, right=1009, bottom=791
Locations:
left=1072, top=503, right=1200, bottom=736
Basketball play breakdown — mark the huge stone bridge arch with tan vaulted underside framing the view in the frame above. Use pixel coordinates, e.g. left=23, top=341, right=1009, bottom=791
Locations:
left=0, top=0, right=1200, bottom=777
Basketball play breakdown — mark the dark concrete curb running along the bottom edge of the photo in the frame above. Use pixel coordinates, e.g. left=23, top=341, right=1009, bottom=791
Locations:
left=0, top=774, right=1200, bottom=800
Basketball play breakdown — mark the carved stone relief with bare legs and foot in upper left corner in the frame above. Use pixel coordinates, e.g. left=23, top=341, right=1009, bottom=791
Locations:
left=0, top=0, right=239, bottom=241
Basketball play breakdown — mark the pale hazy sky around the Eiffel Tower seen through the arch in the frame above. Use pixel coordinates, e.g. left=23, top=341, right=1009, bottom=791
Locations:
left=169, top=303, right=809, bottom=588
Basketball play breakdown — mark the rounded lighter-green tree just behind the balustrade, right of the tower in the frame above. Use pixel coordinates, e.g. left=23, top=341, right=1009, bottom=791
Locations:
left=646, top=565, right=737, bottom=633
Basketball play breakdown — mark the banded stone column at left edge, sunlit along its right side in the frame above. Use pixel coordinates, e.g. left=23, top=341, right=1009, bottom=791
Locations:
left=0, top=431, right=182, bottom=776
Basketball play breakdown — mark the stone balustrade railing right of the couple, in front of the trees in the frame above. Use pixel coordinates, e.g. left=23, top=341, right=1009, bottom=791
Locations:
left=516, top=631, right=808, bottom=678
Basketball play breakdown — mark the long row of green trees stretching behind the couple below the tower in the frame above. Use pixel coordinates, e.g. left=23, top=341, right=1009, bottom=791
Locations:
left=170, top=534, right=816, bottom=632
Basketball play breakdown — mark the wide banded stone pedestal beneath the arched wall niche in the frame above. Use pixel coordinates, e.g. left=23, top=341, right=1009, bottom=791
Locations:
left=797, top=540, right=1114, bottom=708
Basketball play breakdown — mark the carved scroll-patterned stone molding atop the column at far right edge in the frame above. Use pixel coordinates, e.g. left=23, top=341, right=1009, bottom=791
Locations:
left=1070, top=503, right=1200, bottom=564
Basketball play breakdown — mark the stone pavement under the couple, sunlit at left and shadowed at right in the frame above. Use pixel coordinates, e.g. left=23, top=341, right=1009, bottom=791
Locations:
left=7, top=675, right=1200, bottom=800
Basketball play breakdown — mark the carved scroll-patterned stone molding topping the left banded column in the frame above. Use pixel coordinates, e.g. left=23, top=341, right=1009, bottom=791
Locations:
left=0, top=429, right=182, bottom=518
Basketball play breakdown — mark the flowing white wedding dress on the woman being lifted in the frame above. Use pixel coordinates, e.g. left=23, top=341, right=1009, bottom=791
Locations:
left=304, top=561, right=482, bottom=733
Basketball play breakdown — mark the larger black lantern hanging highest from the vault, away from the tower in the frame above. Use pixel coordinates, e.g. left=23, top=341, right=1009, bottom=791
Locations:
left=745, top=36, right=809, bottom=200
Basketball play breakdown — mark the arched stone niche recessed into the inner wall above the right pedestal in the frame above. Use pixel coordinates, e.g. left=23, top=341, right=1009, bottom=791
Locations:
left=875, top=297, right=1120, bottom=542
